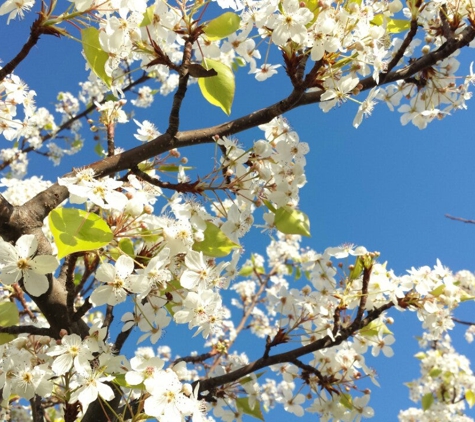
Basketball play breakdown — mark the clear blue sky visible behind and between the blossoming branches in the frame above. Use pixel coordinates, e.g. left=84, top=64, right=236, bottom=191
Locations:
left=0, top=7, right=475, bottom=422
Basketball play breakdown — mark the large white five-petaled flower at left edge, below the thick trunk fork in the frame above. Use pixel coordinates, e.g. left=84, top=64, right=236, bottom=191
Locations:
left=0, top=234, right=59, bottom=296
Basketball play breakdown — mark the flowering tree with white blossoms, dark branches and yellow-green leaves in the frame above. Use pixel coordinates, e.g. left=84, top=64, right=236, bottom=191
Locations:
left=0, top=0, right=475, bottom=422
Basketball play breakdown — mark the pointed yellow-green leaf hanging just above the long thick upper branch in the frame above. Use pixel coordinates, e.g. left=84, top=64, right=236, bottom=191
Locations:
left=198, top=59, right=236, bottom=116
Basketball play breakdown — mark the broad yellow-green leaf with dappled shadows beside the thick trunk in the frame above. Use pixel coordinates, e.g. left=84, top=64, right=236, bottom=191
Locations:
left=48, top=208, right=114, bottom=259
